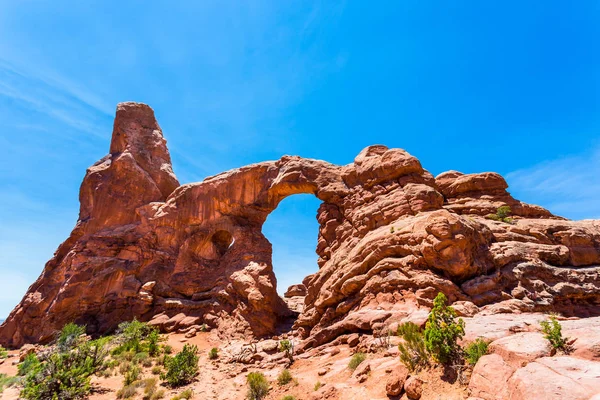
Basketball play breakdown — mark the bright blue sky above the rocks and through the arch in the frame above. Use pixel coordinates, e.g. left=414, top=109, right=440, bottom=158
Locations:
left=0, top=0, right=600, bottom=318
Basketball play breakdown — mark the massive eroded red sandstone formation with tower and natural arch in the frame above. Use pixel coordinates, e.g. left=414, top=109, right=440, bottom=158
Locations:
left=0, top=103, right=600, bottom=350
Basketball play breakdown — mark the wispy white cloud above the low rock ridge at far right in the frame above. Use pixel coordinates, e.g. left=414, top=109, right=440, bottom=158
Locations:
left=506, top=146, right=600, bottom=219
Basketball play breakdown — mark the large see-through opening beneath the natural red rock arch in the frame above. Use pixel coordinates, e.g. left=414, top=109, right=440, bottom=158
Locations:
left=262, top=194, right=321, bottom=332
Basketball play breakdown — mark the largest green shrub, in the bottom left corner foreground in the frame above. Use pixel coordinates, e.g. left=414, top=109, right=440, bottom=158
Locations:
left=21, top=336, right=108, bottom=400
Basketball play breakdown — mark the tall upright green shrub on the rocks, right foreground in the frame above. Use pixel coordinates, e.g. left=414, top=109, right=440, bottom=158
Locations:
left=424, top=292, right=465, bottom=364
